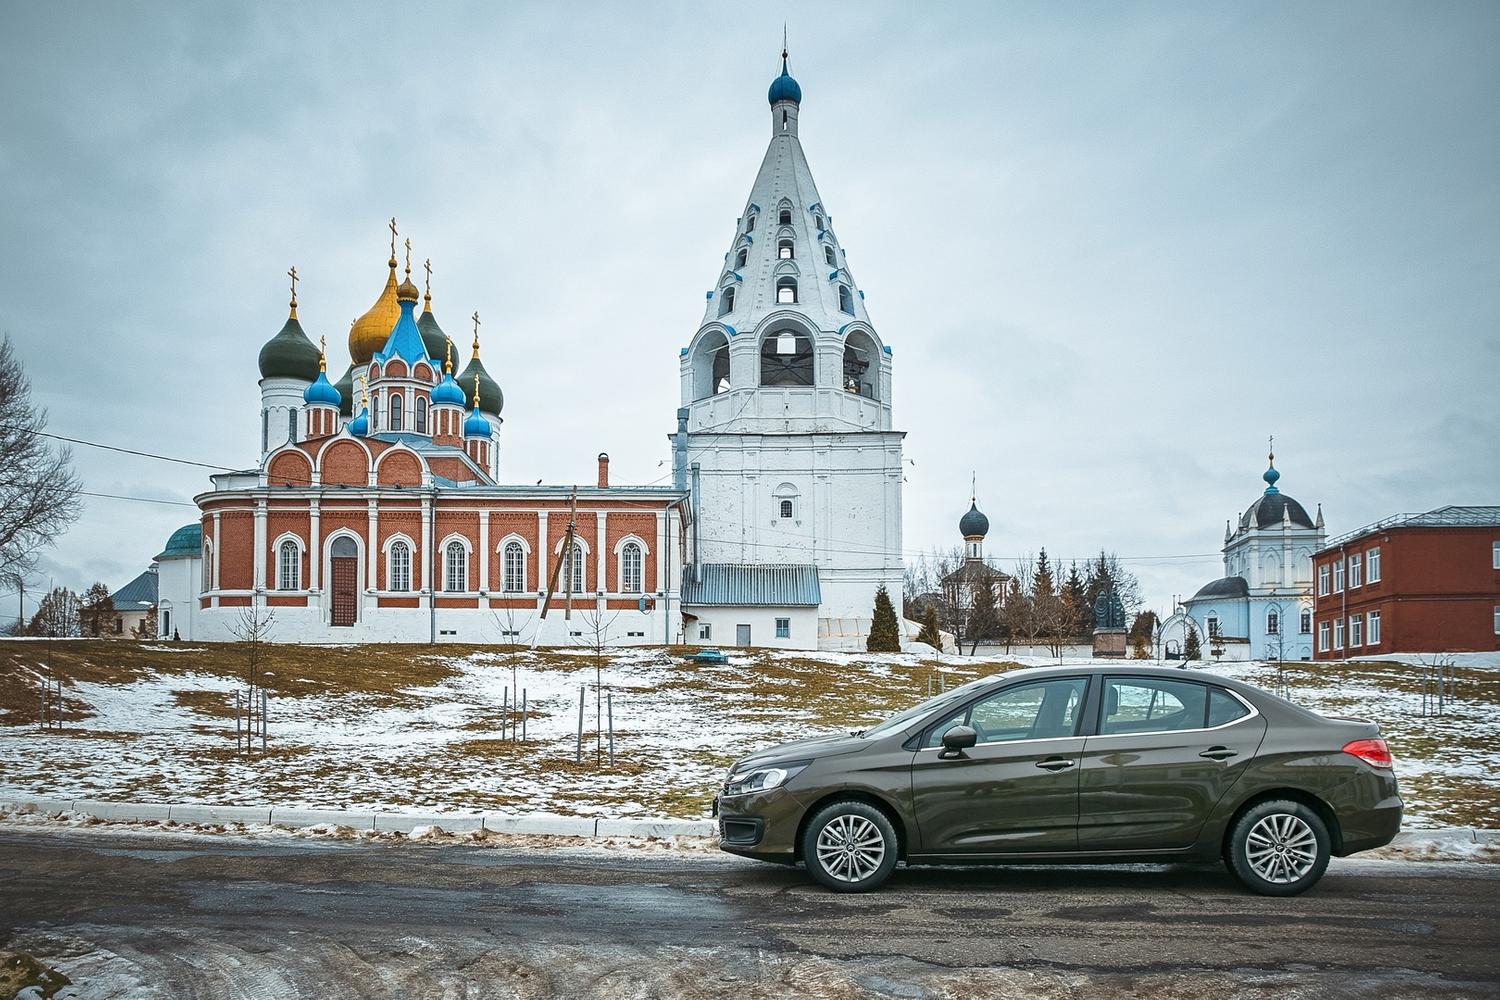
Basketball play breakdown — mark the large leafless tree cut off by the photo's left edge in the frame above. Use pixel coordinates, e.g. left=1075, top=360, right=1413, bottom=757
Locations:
left=0, top=334, right=80, bottom=576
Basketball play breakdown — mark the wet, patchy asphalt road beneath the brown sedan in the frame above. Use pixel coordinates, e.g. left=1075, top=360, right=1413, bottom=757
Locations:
left=0, top=831, right=1500, bottom=1000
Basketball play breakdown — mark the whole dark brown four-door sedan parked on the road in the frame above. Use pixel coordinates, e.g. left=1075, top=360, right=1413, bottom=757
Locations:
left=714, top=663, right=1401, bottom=895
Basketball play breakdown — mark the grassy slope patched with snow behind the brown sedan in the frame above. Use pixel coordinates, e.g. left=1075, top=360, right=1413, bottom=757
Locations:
left=0, top=643, right=1500, bottom=828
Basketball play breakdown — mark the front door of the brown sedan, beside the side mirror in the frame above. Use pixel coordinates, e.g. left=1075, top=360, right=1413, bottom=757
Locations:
left=912, top=675, right=1088, bottom=856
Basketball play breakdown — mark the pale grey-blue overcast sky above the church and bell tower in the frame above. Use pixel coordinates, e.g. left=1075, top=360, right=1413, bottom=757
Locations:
left=0, top=0, right=1500, bottom=620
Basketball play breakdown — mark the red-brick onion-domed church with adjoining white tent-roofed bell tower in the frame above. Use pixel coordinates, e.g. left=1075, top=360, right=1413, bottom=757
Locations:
left=158, top=51, right=903, bottom=649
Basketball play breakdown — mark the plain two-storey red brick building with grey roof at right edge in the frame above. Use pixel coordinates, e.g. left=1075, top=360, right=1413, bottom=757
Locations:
left=1313, top=507, right=1500, bottom=660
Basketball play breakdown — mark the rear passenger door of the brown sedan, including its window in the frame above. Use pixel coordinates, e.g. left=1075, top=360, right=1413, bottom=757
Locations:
left=1079, top=675, right=1266, bottom=853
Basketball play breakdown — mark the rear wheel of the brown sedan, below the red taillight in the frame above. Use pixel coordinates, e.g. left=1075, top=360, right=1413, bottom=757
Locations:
left=1224, top=799, right=1332, bottom=897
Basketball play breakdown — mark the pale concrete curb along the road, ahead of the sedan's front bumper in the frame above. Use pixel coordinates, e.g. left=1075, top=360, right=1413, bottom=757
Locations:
left=0, top=799, right=717, bottom=840
